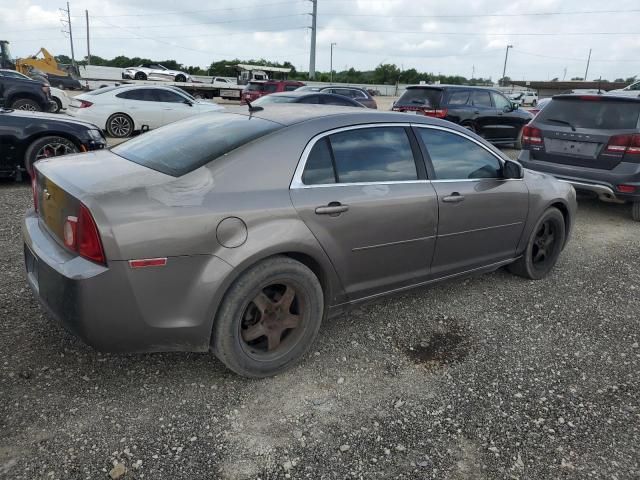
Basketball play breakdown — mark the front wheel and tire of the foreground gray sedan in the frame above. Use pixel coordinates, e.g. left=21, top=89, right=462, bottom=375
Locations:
left=507, top=207, right=566, bottom=280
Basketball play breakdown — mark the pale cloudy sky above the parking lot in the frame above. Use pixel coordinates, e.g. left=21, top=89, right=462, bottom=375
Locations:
left=0, top=0, right=640, bottom=80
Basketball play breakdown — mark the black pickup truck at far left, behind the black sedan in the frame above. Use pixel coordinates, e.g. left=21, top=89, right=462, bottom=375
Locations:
left=0, top=75, right=51, bottom=112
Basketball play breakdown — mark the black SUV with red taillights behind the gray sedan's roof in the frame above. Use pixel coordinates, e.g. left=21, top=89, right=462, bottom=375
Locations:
left=393, top=85, right=533, bottom=148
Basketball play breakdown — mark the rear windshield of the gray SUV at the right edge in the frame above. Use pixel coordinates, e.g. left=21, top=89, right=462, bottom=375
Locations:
left=536, top=97, right=640, bottom=130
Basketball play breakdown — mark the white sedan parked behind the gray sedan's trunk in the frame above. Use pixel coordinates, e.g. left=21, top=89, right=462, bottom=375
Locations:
left=67, top=85, right=224, bottom=138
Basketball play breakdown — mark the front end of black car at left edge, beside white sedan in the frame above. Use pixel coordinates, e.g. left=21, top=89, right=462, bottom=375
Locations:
left=0, top=108, right=107, bottom=180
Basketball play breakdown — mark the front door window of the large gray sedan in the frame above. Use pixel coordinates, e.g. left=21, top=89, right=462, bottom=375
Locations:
left=417, top=128, right=502, bottom=180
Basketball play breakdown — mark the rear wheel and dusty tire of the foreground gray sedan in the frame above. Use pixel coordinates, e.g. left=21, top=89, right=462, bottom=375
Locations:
left=211, top=256, right=324, bottom=378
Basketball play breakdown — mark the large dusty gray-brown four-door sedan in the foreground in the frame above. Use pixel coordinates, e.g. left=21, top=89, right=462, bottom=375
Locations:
left=23, top=105, right=576, bottom=377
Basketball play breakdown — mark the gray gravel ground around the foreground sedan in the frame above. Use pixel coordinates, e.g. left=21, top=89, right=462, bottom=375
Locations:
left=0, top=171, right=640, bottom=480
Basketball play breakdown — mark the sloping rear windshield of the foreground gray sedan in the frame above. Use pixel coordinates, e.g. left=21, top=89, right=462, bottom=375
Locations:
left=111, top=112, right=283, bottom=177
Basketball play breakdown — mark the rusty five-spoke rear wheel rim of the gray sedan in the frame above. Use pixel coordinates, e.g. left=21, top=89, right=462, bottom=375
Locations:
left=240, top=281, right=306, bottom=358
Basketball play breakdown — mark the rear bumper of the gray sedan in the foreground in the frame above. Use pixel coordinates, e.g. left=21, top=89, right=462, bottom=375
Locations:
left=22, top=211, right=231, bottom=352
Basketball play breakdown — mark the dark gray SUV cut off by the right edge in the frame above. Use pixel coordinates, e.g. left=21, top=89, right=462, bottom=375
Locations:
left=518, top=95, right=640, bottom=221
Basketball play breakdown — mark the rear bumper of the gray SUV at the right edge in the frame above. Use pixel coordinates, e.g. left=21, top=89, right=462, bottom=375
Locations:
left=518, top=150, right=640, bottom=202
